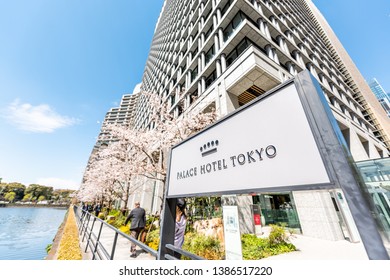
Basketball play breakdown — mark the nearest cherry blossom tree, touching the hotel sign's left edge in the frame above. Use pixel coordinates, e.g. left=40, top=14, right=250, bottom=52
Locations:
left=106, top=93, right=217, bottom=206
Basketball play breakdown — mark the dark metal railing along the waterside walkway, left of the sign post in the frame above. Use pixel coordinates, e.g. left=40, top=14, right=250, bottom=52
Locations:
left=74, top=206, right=157, bottom=260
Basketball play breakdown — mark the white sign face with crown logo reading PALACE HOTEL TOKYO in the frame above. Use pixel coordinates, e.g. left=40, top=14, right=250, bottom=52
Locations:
left=168, top=83, right=330, bottom=197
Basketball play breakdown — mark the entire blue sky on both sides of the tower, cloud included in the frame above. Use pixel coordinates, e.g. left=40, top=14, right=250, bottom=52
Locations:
left=0, top=0, right=390, bottom=189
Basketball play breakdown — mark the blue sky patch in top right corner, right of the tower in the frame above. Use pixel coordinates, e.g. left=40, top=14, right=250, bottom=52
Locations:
left=313, top=0, right=390, bottom=92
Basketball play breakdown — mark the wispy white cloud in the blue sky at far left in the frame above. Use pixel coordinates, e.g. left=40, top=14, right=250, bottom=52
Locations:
left=5, top=99, right=77, bottom=133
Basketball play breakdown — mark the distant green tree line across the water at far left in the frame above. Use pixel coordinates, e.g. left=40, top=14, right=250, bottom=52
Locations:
left=0, top=182, right=75, bottom=204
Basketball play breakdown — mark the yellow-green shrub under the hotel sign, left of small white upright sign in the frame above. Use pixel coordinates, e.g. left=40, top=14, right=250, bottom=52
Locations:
left=183, top=232, right=224, bottom=260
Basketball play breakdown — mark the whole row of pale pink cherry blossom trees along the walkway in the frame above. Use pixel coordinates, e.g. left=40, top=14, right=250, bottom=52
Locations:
left=78, top=93, right=217, bottom=210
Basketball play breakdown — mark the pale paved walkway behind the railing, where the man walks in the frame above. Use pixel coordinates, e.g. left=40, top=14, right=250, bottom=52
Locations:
left=79, top=211, right=156, bottom=261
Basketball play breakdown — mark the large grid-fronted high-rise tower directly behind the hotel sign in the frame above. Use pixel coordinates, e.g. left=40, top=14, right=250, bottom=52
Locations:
left=134, top=0, right=390, bottom=248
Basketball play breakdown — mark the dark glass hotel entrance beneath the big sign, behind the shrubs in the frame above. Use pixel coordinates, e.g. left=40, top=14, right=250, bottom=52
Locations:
left=252, top=192, right=301, bottom=230
